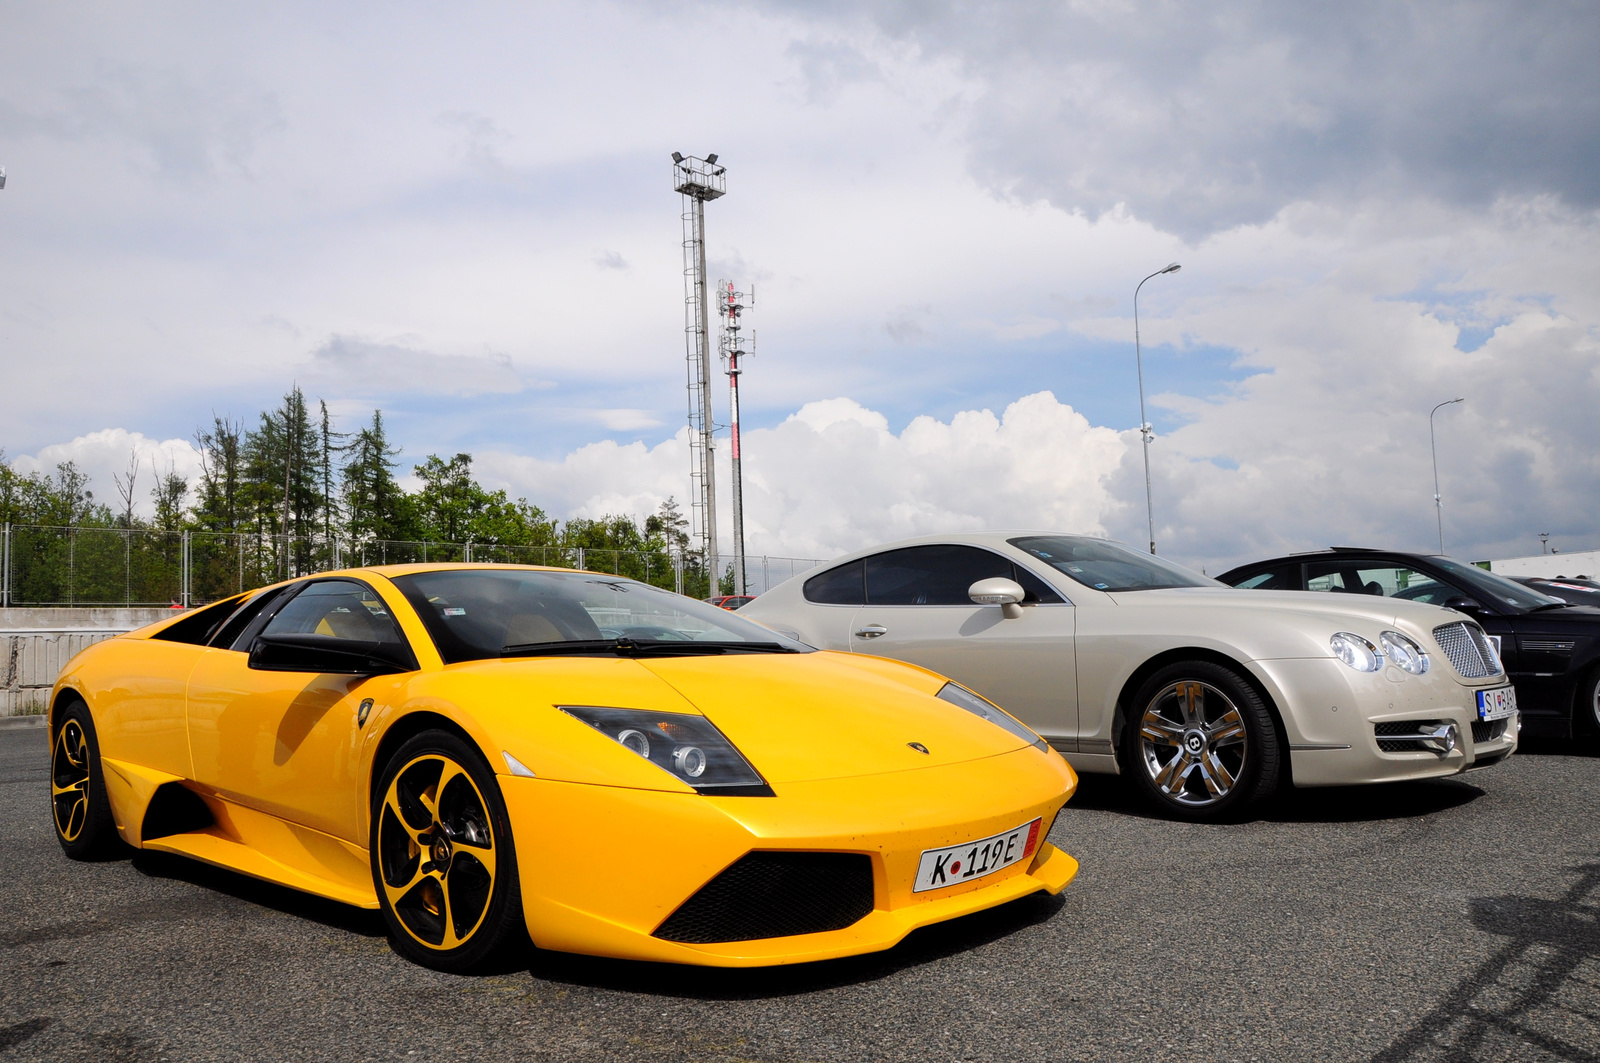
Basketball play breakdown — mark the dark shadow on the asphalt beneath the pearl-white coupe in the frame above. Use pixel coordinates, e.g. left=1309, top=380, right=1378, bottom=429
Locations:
left=1067, top=775, right=1485, bottom=826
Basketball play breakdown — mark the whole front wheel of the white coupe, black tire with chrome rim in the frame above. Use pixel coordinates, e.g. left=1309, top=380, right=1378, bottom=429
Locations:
left=1118, top=661, right=1282, bottom=821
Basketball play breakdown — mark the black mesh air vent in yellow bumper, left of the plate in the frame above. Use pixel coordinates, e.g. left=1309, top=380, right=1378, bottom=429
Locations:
left=654, top=852, right=874, bottom=945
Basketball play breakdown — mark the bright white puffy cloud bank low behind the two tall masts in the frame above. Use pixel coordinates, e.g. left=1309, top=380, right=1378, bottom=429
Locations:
left=475, top=392, right=1128, bottom=557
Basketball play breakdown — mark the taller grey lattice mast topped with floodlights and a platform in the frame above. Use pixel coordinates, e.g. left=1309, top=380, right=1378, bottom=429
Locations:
left=672, top=152, right=728, bottom=576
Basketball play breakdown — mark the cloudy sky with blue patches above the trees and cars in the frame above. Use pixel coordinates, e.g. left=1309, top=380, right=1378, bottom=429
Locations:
left=0, top=0, right=1600, bottom=572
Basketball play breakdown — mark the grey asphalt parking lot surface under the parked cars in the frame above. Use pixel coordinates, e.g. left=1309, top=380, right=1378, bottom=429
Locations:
left=0, top=728, right=1600, bottom=1063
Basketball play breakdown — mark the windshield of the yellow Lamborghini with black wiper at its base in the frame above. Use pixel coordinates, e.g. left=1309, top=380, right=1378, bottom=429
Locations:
left=395, top=568, right=811, bottom=664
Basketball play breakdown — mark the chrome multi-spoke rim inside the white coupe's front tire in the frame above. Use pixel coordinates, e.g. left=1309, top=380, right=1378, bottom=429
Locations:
left=1139, top=679, right=1250, bottom=805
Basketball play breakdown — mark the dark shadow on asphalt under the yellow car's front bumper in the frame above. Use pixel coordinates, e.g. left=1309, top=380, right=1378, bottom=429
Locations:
left=526, top=893, right=1064, bottom=1001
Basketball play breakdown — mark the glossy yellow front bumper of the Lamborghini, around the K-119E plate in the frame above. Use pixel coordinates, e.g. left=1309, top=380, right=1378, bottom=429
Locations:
left=499, top=748, right=1078, bottom=967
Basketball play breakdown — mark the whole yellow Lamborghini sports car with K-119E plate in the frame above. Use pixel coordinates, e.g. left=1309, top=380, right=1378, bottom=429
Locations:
left=50, top=565, right=1077, bottom=970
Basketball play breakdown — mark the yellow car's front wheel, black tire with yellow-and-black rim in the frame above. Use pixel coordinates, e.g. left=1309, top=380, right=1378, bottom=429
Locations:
left=370, top=730, right=526, bottom=973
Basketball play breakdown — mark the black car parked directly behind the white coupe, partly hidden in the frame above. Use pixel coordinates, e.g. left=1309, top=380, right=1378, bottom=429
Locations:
left=1218, top=546, right=1600, bottom=738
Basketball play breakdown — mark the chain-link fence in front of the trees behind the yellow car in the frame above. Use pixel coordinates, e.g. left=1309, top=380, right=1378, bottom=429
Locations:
left=0, top=523, right=821, bottom=607
